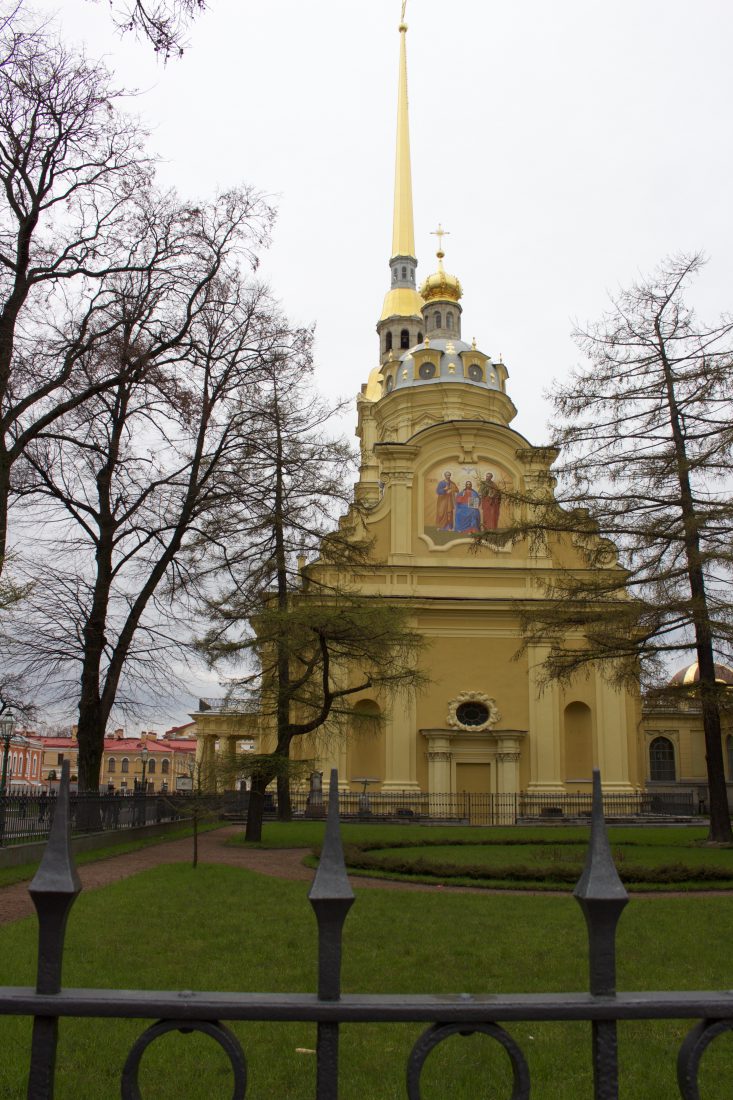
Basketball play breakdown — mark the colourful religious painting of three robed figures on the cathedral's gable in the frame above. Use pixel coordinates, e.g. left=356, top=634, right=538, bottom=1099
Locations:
left=424, top=461, right=511, bottom=546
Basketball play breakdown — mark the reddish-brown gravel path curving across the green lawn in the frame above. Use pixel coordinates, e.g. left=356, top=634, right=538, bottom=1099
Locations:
left=0, top=825, right=717, bottom=924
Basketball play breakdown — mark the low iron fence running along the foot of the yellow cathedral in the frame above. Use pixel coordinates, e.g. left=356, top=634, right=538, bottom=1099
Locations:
left=223, top=791, right=702, bottom=825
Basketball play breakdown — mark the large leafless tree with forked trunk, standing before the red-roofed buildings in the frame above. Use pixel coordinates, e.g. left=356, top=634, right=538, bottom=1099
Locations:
left=6, top=193, right=283, bottom=789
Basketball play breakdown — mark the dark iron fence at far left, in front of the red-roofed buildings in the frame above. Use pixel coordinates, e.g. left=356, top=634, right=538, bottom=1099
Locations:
left=0, top=791, right=188, bottom=846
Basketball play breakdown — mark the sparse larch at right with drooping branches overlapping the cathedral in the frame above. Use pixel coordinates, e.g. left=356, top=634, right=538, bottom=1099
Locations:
left=473, top=255, right=733, bottom=840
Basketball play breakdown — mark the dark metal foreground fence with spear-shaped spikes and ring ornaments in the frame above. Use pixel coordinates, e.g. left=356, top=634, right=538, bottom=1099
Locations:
left=0, top=762, right=733, bottom=1100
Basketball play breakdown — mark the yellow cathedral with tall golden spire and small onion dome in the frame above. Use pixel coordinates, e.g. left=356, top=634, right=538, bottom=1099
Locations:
left=191, top=12, right=644, bottom=795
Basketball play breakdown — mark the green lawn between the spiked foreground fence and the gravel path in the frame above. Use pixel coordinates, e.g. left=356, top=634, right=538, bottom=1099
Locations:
left=0, top=865, right=733, bottom=1100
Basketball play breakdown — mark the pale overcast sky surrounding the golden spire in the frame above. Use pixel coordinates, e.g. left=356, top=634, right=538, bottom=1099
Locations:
left=28, top=0, right=733, bottom=730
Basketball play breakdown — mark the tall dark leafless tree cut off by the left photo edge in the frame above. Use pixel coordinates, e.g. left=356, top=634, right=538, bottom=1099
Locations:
left=0, top=9, right=151, bottom=570
